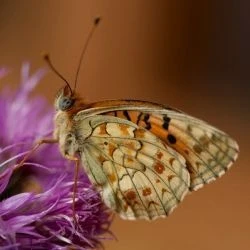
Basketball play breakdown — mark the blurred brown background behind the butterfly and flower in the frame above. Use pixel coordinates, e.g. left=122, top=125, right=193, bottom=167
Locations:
left=0, top=0, right=250, bottom=250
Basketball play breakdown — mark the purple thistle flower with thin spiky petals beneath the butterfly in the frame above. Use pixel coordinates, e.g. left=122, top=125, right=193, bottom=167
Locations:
left=0, top=63, right=110, bottom=249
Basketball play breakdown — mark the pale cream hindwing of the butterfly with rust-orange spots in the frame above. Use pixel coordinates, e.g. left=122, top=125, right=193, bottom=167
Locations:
left=75, top=115, right=190, bottom=219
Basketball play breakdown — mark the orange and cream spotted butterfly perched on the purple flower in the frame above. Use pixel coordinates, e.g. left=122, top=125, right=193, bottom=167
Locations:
left=19, top=18, right=239, bottom=220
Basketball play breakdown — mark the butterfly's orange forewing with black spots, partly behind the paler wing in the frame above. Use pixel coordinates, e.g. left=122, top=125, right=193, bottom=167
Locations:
left=75, top=100, right=239, bottom=190
